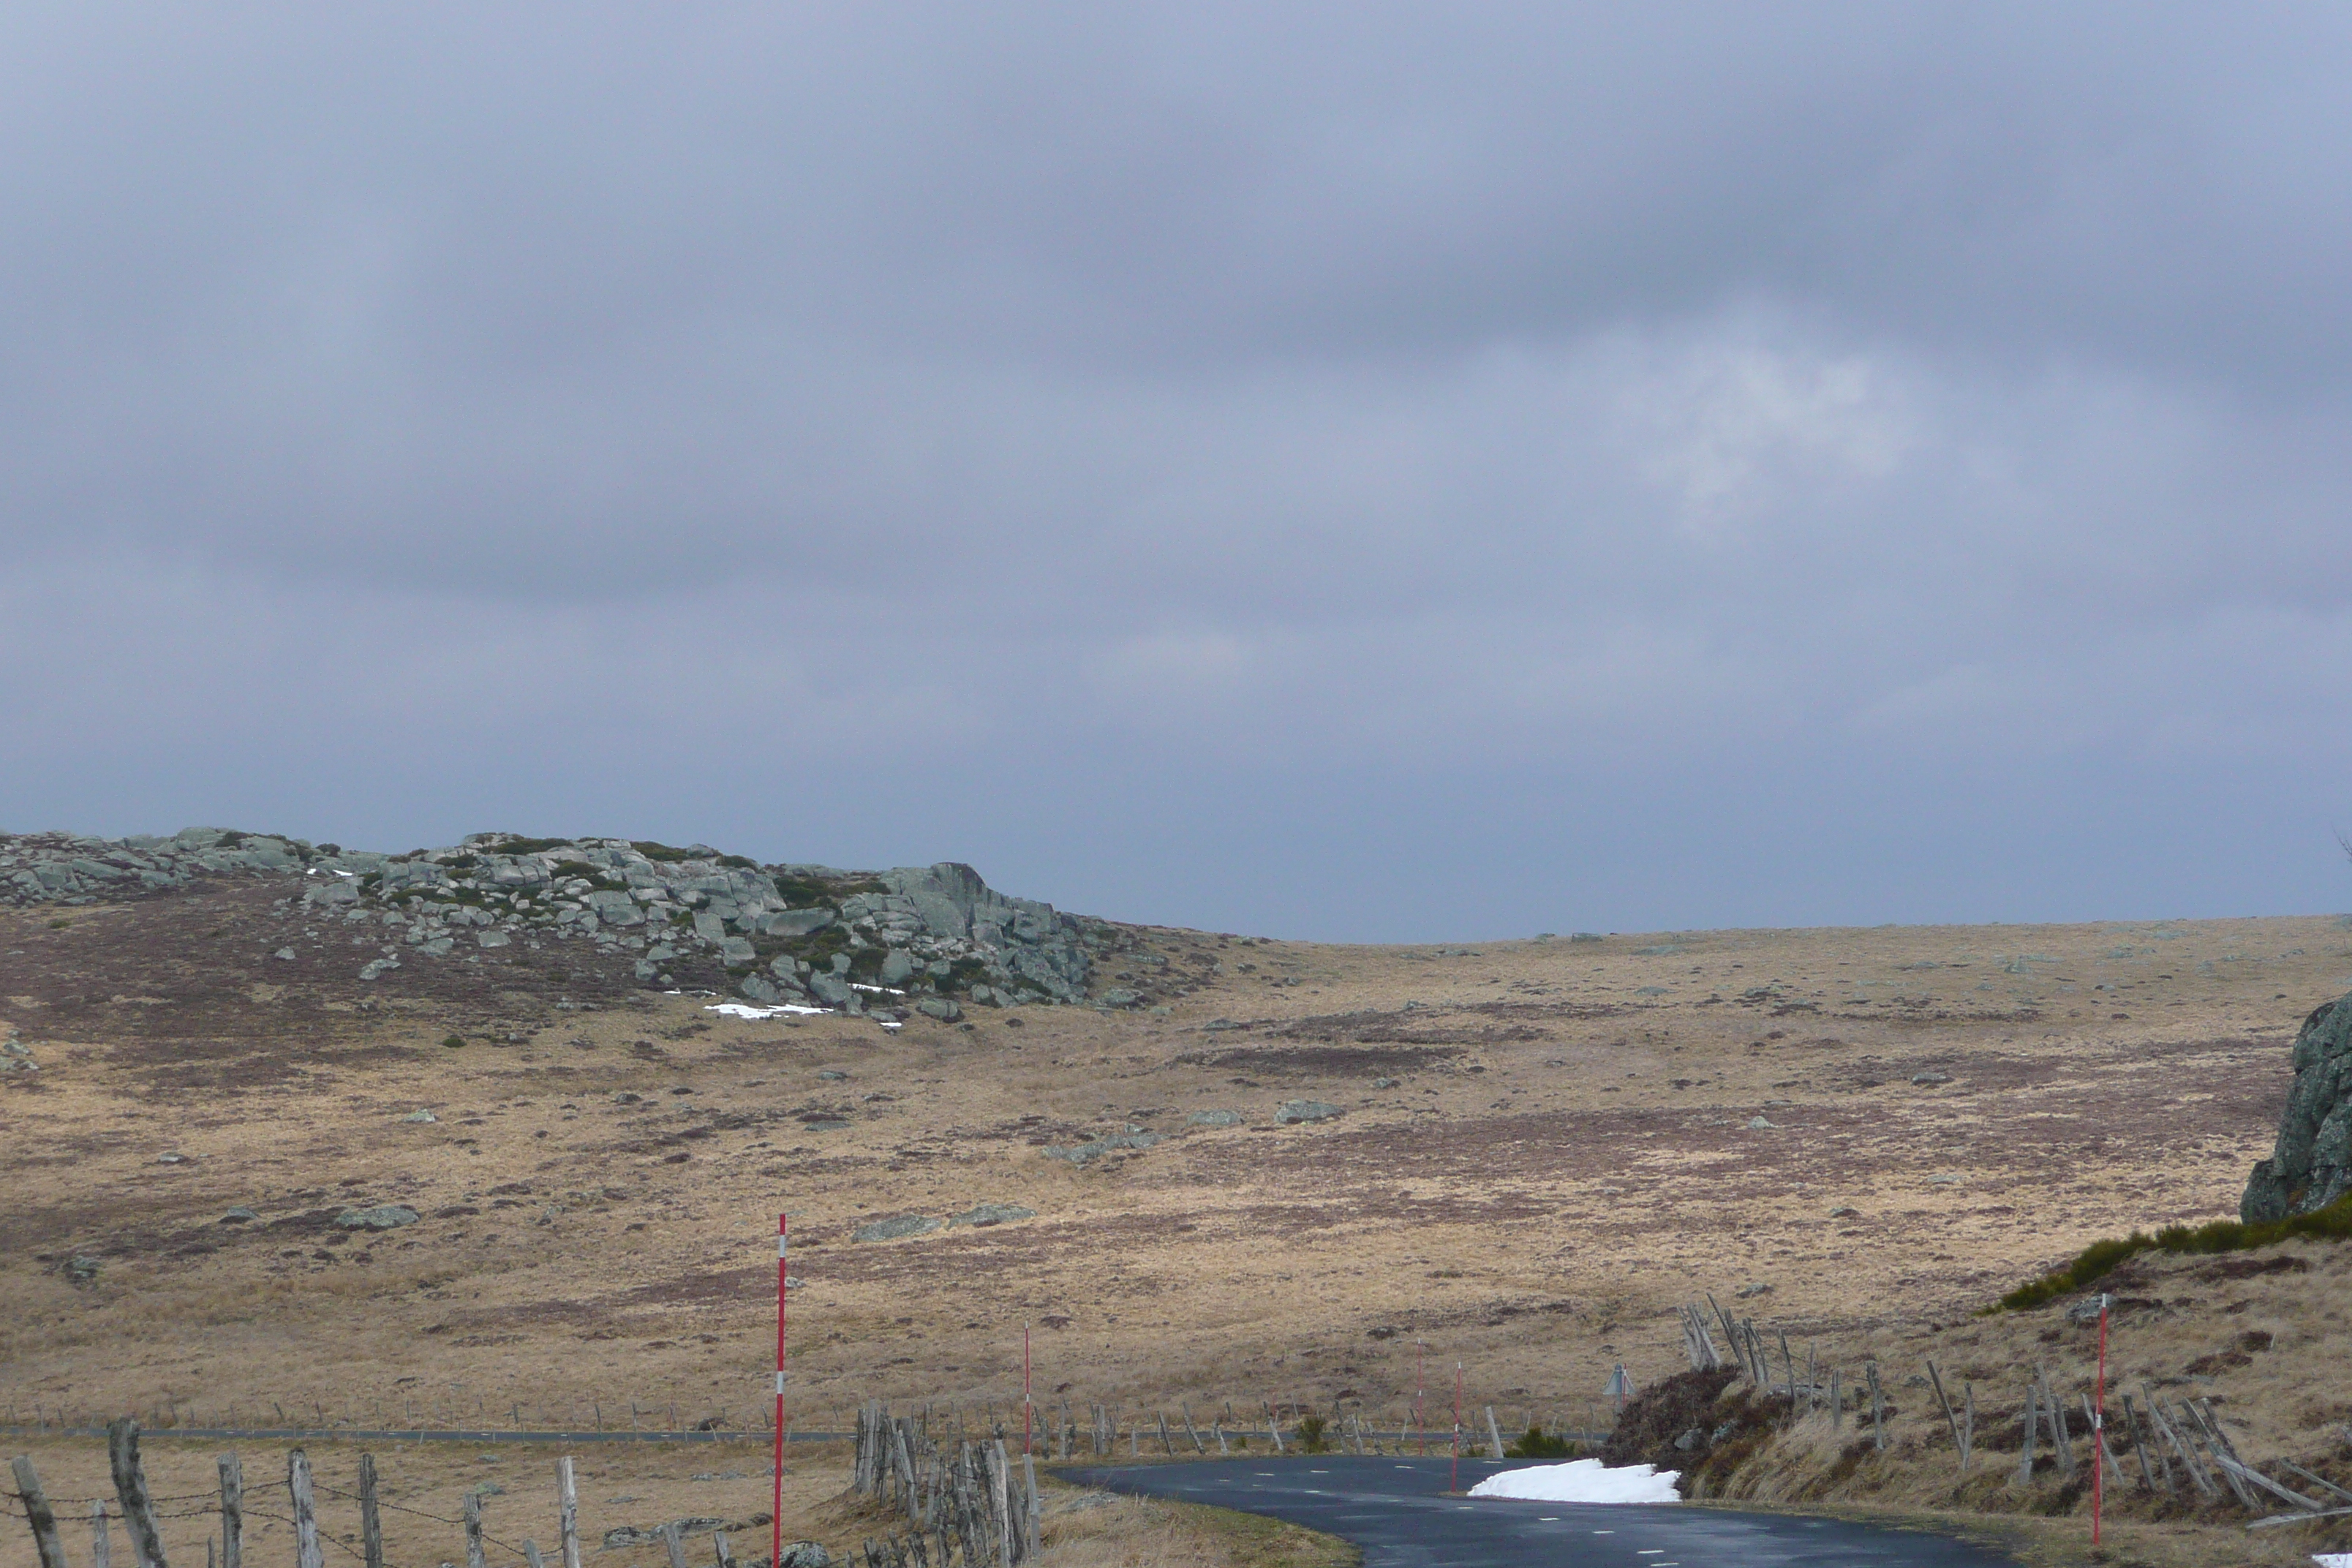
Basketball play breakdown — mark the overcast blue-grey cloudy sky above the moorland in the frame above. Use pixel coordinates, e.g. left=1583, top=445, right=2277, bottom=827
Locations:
left=0, top=0, right=2352, bottom=941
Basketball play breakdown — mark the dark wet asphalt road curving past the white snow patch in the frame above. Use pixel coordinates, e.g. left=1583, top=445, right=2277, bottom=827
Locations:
left=1075, top=1455, right=2016, bottom=1568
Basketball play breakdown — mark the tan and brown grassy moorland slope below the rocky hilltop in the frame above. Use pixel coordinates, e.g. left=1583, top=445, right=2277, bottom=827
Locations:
left=0, top=832, right=2352, bottom=1564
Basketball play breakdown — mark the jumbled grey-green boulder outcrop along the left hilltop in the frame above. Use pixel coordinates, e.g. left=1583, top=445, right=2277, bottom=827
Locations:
left=0, top=827, right=1101, bottom=1018
